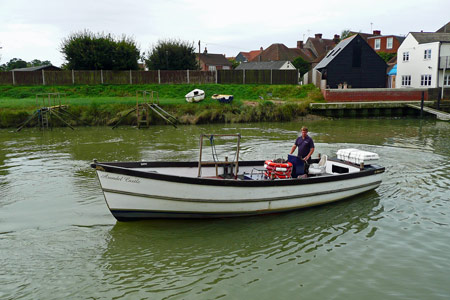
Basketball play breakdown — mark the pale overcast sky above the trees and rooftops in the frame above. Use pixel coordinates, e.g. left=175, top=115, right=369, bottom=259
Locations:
left=0, top=0, right=450, bottom=66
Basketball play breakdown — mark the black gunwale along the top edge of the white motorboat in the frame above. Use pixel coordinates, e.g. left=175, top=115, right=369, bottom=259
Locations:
left=91, top=159, right=385, bottom=187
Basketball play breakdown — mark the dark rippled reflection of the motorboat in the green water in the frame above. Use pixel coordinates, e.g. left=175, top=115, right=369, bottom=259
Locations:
left=102, top=191, right=383, bottom=298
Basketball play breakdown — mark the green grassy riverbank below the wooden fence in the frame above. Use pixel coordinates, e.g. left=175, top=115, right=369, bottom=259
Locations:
left=0, top=84, right=323, bottom=127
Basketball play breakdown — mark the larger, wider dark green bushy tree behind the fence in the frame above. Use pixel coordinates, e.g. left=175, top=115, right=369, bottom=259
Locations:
left=60, top=30, right=140, bottom=70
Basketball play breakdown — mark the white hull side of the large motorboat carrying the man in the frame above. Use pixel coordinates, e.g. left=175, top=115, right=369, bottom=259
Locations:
left=97, top=163, right=382, bottom=220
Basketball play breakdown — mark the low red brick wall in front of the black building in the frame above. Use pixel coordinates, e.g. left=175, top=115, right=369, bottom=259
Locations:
left=322, top=89, right=428, bottom=102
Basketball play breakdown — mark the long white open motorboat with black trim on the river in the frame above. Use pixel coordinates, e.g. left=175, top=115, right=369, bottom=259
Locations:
left=91, top=134, right=385, bottom=221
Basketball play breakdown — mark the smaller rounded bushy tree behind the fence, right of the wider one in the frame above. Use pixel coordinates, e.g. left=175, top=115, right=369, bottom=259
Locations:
left=145, top=39, right=198, bottom=70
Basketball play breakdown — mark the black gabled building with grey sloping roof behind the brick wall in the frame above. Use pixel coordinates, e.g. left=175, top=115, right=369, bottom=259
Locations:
left=314, top=34, right=387, bottom=88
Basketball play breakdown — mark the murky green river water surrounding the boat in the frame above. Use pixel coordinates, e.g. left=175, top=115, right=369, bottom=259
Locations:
left=0, top=119, right=450, bottom=299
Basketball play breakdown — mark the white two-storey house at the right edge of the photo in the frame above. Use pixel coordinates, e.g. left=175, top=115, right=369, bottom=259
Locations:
left=396, top=32, right=450, bottom=88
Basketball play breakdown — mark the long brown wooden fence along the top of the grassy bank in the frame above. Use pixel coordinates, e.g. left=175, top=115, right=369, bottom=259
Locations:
left=0, top=70, right=299, bottom=85
